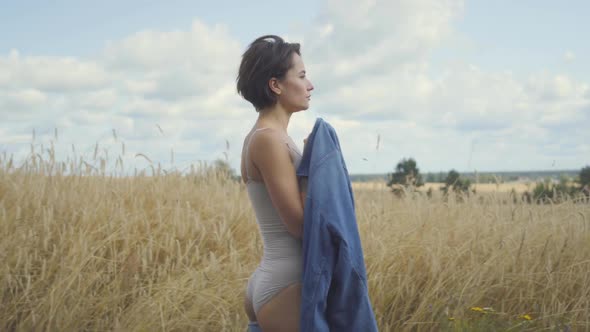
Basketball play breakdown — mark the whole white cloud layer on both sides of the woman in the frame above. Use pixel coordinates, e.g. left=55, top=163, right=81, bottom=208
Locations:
left=0, top=5, right=590, bottom=173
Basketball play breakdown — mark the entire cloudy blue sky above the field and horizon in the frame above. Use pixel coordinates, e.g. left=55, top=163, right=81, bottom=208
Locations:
left=0, top=0, right=590, bottom=174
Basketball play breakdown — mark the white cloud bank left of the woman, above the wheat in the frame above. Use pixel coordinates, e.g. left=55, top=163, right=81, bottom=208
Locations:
left=0, top=20, right=253, bottom=174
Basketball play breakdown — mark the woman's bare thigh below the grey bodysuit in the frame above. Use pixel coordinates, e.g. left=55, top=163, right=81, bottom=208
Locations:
left=256, top=283, right=301, bottom=332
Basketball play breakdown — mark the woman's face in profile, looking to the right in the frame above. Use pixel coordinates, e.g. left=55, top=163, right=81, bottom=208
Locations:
left=278, top=53, right=313, bottom=112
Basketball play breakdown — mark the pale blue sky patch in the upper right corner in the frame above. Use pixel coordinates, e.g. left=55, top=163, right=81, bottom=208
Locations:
left=446, top=0, right=590, bottom=78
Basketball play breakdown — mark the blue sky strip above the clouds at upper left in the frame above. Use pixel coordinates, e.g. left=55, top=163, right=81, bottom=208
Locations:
left=0, top=0, right=320, bottom=56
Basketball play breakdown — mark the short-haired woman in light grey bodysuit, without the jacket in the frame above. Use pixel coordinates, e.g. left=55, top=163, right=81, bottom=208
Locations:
left=237, top=35, right=313, bottom=332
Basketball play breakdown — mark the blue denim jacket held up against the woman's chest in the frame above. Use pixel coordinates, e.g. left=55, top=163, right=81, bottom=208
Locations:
left=297, top=118, right=377, bottom=332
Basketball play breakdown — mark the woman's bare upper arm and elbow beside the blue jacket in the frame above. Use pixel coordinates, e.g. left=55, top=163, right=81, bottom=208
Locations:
left=250, top=130, right=303, bottom=238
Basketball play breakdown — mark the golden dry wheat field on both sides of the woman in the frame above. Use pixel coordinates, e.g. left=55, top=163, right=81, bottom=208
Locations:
left=0, top=148, right=590, bottom=331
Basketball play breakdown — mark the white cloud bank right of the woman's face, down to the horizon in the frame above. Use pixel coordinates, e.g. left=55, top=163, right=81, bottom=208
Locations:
left=294, top=0, right=590, bottom=171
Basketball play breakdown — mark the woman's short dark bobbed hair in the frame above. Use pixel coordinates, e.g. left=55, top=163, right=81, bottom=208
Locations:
left=236, top=35, right=301, bottom=112
